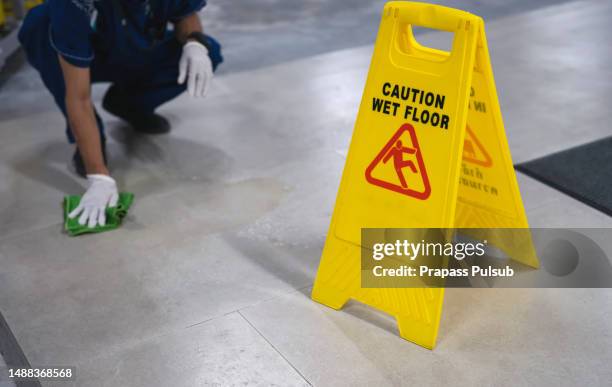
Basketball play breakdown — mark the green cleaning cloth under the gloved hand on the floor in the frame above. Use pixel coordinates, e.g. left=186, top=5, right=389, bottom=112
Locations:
left=64, top=192, right=134, bottom=236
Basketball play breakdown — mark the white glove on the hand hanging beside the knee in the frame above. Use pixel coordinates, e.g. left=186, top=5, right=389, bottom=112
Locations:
left=178, top=41, right=213, bottom=97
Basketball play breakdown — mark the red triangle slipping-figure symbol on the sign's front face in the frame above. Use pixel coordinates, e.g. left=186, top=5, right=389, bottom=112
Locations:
left=365, top=124, right=431, bottom=200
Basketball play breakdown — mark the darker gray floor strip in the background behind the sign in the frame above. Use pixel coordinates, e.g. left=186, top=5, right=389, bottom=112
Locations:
left=203, top=0, right=580, bottom=71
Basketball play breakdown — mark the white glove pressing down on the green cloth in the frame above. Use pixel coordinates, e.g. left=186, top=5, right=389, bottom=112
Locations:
left=68, top=175, right=119, bottom=228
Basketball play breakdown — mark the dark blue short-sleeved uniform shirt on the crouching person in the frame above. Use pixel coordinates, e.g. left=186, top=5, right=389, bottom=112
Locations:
left=48, top=0, right=206, bottom=67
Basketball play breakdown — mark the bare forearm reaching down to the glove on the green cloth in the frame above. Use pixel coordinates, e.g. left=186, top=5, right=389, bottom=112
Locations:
left=58, top=55, right=109, bottom=175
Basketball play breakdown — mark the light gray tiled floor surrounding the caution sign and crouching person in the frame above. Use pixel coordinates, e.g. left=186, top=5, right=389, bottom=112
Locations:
left=0, top=0, right=612, bottom=386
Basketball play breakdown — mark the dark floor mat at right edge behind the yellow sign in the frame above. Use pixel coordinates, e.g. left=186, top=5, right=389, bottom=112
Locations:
left=516, top=137, right=612, bottom=216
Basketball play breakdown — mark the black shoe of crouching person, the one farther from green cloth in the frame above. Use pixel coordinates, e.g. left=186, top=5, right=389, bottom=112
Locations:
left=102, top=85, right=170, bottom=134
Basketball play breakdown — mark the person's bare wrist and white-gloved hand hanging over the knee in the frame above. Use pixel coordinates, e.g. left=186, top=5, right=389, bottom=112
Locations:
left=175, top=12, right=213, bottom=97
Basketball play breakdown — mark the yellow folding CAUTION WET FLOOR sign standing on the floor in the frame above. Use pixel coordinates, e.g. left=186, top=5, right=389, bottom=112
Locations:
left=312, top=1, right=537, bottom=349
